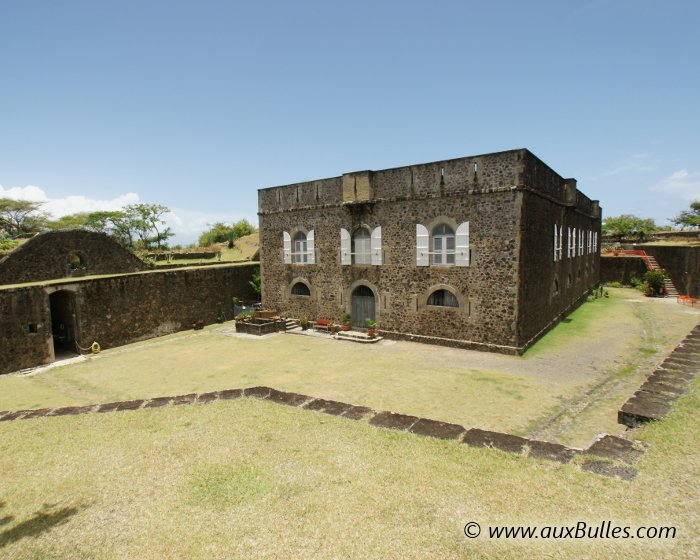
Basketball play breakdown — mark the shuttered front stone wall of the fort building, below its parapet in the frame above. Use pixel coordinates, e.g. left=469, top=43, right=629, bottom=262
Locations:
left=260, top=191, right=516, bottom=346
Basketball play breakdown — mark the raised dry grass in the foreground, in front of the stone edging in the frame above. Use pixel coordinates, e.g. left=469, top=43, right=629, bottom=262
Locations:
left=0, top=384, right=700, bottom=560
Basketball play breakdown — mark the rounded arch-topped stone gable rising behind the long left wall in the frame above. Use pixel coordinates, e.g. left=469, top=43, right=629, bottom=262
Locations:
left=0, top=230, right=148, bottom=285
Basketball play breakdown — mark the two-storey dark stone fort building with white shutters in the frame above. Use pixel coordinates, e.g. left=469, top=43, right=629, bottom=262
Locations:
left=258, top=149, right=601, bottom=354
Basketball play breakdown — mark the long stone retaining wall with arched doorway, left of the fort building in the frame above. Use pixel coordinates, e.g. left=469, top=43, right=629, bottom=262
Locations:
left=0, top=263, right=257, bottom=373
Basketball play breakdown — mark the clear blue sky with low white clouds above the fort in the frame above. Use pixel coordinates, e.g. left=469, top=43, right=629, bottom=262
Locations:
left=0, top=0, right=700, bottom=242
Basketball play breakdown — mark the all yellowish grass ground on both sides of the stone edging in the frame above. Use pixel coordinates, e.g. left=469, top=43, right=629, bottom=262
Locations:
left=0, top=290, right=700, bottom=559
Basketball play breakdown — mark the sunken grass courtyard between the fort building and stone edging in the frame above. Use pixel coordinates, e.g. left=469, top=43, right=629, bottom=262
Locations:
left=0, top=290, right=698, bottom=447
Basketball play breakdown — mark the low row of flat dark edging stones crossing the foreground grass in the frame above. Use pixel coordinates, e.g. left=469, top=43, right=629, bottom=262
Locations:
left=0, top=386, right=643, bottom=480
